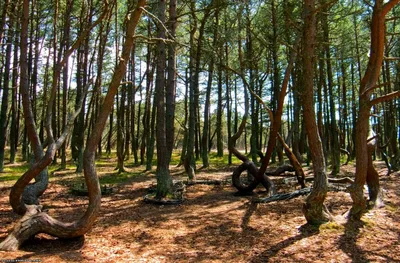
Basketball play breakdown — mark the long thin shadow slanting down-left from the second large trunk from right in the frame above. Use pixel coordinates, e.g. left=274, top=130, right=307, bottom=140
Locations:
left=249, top=224, right=319, bottom=262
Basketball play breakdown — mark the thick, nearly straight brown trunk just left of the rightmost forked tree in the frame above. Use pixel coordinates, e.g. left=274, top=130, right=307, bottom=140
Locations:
left=302, top=0, right=330, bottom=224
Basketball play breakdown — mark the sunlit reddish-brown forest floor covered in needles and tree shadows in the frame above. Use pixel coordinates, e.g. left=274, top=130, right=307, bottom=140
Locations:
left=0, top=158, right=400, bottom=262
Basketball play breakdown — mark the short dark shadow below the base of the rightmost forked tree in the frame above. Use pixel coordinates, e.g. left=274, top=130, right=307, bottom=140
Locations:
left=338, top=220, right=370, bottom=262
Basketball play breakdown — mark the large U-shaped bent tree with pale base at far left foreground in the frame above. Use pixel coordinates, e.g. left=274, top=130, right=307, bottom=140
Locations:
left=0, top=0, right=146, bottom=250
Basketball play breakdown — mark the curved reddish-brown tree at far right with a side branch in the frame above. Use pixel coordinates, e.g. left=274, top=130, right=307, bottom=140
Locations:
left=349, top=0, right=400, bottom=220
